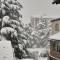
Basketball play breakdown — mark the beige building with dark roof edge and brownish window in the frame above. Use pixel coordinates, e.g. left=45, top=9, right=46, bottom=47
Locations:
left=51, top=18, right=60, bottom=34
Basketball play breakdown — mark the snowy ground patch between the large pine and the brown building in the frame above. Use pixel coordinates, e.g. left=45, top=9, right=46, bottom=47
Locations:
left=28, top=48, right=48, bottom=60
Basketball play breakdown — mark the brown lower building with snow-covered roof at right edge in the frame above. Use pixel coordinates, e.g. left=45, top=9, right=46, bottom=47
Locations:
left=49, top=32, right=60, bottom=60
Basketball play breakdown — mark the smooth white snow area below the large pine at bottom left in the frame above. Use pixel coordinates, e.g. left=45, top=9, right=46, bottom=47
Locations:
left=0, top=40, right=14, bottom=60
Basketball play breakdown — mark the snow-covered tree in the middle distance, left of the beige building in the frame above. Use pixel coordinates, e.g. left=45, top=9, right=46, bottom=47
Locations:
left=31, top=18, right=49, bottom=48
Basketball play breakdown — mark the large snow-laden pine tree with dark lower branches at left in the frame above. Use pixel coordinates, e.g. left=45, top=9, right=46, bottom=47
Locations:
left=0, top=0, right=29, bottom=59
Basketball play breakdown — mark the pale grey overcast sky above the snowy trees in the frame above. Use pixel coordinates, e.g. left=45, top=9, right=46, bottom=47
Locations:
left=22, top=0, right=60, bottom=23
